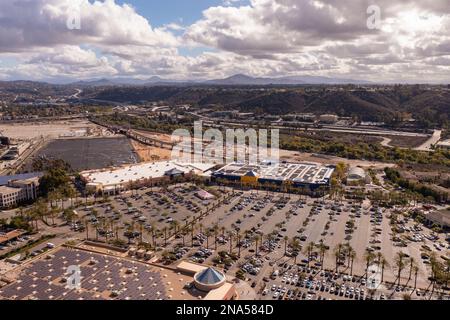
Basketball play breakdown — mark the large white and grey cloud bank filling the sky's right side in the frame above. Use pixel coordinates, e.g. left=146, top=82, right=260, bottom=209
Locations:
left=185, top=0, right=450, bottom=81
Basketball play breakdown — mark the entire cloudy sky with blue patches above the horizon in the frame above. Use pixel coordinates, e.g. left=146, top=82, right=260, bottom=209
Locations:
left=0, top=0, right=450, bottom=83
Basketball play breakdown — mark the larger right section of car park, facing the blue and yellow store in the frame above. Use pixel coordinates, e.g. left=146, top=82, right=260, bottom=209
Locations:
left=156, top=191, right=448, bottom=299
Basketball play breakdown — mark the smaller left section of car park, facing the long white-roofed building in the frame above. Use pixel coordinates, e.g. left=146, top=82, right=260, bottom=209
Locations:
left=72, top=184, right=220, bottom=243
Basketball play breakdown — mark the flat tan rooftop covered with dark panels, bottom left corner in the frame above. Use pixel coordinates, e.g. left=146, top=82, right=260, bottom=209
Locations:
left=0, top=247, right=205, bottom=300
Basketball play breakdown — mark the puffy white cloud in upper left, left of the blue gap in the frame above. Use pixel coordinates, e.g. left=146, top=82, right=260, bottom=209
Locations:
left=0, top=0, right=177, bottom=52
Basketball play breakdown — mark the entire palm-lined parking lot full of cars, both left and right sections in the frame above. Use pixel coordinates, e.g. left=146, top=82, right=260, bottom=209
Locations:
left=1, top=184, right=449, bottom=300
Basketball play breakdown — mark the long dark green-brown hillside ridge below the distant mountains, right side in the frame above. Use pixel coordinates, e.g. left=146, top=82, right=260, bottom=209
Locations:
left=85, top=86, right=450, bottom=126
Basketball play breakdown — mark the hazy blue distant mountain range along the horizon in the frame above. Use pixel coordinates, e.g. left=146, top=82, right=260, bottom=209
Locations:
left=65, top=74, right=371, bottom=87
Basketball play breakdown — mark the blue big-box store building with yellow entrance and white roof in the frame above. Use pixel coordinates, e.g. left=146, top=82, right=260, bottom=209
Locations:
left=212, top=162, right=335, bottom=191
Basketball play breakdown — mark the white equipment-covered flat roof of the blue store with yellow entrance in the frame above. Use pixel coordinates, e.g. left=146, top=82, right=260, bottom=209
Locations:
left=214, top=162, right=334, bottom=184
